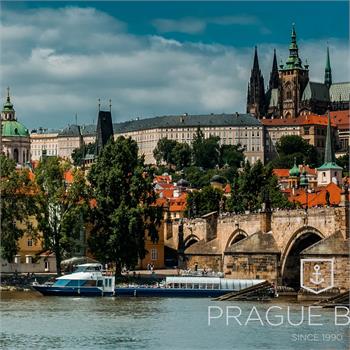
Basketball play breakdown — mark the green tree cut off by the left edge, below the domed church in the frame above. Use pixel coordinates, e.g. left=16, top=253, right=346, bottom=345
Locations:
left=0, top=155, right=36, bottom=262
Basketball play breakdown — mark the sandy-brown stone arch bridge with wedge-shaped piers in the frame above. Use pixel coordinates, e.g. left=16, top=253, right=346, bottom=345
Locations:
left=165, top=207, right=349, bottom=288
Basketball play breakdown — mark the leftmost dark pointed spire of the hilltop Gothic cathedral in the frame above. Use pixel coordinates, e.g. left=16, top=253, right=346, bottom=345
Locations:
left=247, top=46, right=265, bottom=118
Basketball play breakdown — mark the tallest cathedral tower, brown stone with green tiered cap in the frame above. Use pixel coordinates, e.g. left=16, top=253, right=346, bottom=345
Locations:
left=279, top=24, right=309, bottom=118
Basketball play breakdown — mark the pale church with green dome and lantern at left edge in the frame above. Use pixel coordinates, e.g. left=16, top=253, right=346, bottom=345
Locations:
left=0, top=88, right=30, bottom=165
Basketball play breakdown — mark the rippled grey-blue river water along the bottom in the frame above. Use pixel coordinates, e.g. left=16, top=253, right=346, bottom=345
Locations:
left=0, top=292, right=349, bottom=350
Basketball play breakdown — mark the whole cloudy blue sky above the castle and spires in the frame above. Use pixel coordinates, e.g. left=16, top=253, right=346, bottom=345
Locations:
left=0, top=1, right=350, bottom=129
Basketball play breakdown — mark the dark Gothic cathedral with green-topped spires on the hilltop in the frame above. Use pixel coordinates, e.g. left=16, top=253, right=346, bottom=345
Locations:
left=247, top=24, right=350, bottom=119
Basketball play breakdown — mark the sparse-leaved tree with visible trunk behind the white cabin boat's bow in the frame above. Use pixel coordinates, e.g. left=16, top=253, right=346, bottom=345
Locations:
left=35, top=157, right=89, bottom=275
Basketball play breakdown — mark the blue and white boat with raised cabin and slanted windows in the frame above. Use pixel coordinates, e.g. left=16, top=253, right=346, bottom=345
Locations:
left=32, top=263, right=115, bottom=296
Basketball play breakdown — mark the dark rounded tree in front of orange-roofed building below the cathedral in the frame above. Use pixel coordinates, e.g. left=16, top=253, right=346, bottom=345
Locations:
left=271, top=135, right=320, bottom=168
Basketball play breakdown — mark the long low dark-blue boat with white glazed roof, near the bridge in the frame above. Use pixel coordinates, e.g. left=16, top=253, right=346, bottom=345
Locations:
left=115, top=276, right=265, bottom=298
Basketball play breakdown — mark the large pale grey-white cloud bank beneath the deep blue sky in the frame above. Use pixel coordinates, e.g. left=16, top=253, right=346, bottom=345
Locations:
left=0, top=7, right=349, bottom=128
